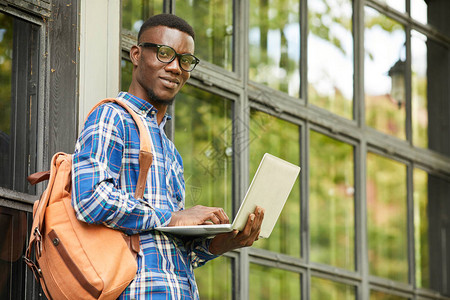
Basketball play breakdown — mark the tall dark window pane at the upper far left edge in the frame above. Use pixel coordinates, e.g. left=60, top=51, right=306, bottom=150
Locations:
left=0, top=13, right=40, bottom=193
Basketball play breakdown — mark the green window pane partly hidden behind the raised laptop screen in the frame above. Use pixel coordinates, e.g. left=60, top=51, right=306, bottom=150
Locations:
left=250, top=110, right=300, bottom=257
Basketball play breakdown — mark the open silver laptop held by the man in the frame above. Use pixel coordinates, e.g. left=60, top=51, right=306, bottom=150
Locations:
left=156, top=153, right=300, bottom=238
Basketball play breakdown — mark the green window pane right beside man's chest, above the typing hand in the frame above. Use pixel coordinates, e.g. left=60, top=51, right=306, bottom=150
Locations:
left=175, top=85, right=233, bottom=218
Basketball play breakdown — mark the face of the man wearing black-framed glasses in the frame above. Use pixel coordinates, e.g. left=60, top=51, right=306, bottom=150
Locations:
left=129, top=26, right=194, bottom=105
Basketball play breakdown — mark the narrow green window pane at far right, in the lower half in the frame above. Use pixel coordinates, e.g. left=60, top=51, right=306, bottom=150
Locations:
left=414, top=169, right=430, bottom=288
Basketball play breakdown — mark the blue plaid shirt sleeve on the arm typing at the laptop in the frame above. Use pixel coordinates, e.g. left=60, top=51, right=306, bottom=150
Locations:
left=72, top=104, right=172, bottom=234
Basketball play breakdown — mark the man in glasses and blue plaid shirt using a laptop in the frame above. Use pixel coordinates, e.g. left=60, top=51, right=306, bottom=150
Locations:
left=72, top=14, right=264, bottom=299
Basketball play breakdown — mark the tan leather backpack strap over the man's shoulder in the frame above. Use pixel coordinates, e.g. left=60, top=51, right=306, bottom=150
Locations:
left=86, top=98, right=153, bottom=199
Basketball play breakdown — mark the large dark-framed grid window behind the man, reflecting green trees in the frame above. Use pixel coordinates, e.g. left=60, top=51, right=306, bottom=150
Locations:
left=121, top=0, right=450, bottom=300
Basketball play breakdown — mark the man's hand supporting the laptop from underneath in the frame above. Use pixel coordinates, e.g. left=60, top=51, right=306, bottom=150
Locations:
left=209, top=206, right=264, bottom=255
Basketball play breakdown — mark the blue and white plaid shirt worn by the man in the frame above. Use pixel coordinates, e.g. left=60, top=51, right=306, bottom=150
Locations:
left=72, top=92, right=216, bottom=299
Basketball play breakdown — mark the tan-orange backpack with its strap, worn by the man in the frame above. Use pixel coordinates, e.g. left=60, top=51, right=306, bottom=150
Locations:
left=24, top=98, right=153, bottom=300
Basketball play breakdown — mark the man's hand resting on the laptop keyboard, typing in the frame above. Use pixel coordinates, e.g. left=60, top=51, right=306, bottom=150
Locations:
left=168, top=205, right=230, bottom=226
